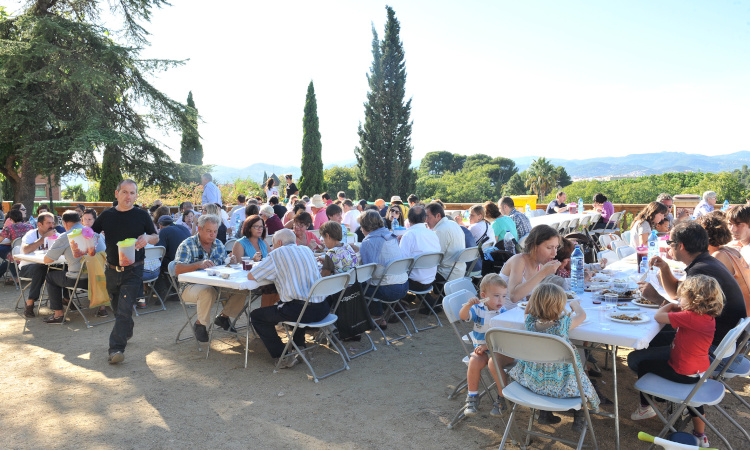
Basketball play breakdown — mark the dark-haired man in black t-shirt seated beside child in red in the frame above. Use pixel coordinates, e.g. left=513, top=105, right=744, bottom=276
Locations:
left=628, top=221, right=747, bottom=371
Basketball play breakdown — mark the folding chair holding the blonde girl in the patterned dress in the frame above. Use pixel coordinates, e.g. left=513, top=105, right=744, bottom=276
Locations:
left=485, top=328, right=598, bottom=450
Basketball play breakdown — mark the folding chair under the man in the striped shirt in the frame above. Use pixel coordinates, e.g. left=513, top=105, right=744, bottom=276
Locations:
left=274, top=270, right=352, bottom=383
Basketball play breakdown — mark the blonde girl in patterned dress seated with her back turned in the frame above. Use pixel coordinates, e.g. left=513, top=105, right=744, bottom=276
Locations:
left=510, top=283, right=599, bottom=431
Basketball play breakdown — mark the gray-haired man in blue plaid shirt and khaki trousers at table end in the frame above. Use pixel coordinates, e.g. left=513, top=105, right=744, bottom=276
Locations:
left=174, top=214, right=246, bottom=342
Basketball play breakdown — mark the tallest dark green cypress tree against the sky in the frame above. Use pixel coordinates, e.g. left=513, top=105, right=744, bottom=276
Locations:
left=354, top=6, right=415, bottom=199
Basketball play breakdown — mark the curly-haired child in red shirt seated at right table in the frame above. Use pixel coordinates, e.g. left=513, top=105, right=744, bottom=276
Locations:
left=630, top=275, right=724, bottom=447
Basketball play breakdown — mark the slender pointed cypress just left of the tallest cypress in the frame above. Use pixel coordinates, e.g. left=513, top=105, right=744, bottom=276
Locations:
left=298, top=81, right=325, bottom=196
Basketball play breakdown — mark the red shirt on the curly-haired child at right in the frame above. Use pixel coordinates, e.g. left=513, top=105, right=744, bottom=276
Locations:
left=668, top=311, right=716, bottom=375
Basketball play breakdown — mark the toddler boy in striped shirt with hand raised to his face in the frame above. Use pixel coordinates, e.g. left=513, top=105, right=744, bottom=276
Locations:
left=458, top=273, right=513, bottom=417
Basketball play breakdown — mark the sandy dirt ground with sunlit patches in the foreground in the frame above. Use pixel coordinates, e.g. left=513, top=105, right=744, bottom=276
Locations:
left=0, top=286, right=750, bottom=449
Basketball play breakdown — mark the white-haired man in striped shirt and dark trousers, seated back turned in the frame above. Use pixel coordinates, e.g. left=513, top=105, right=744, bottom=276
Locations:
left=247, top=229, right=329, bottom=369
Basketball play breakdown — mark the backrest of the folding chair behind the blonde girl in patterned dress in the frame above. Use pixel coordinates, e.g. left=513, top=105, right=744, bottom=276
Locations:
left=485, top=328, right=577, bottom=371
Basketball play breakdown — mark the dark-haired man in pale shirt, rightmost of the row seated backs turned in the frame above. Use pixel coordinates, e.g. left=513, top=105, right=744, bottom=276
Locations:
left=425, top=202, right=466, bottom=284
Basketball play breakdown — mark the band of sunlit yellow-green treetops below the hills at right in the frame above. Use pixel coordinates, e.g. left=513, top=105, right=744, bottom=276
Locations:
left=560, top=172, right=748, bottom=204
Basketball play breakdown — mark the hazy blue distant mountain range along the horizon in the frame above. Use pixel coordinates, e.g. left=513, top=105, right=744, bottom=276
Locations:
left=206, top=151, right=750, bottom=182
